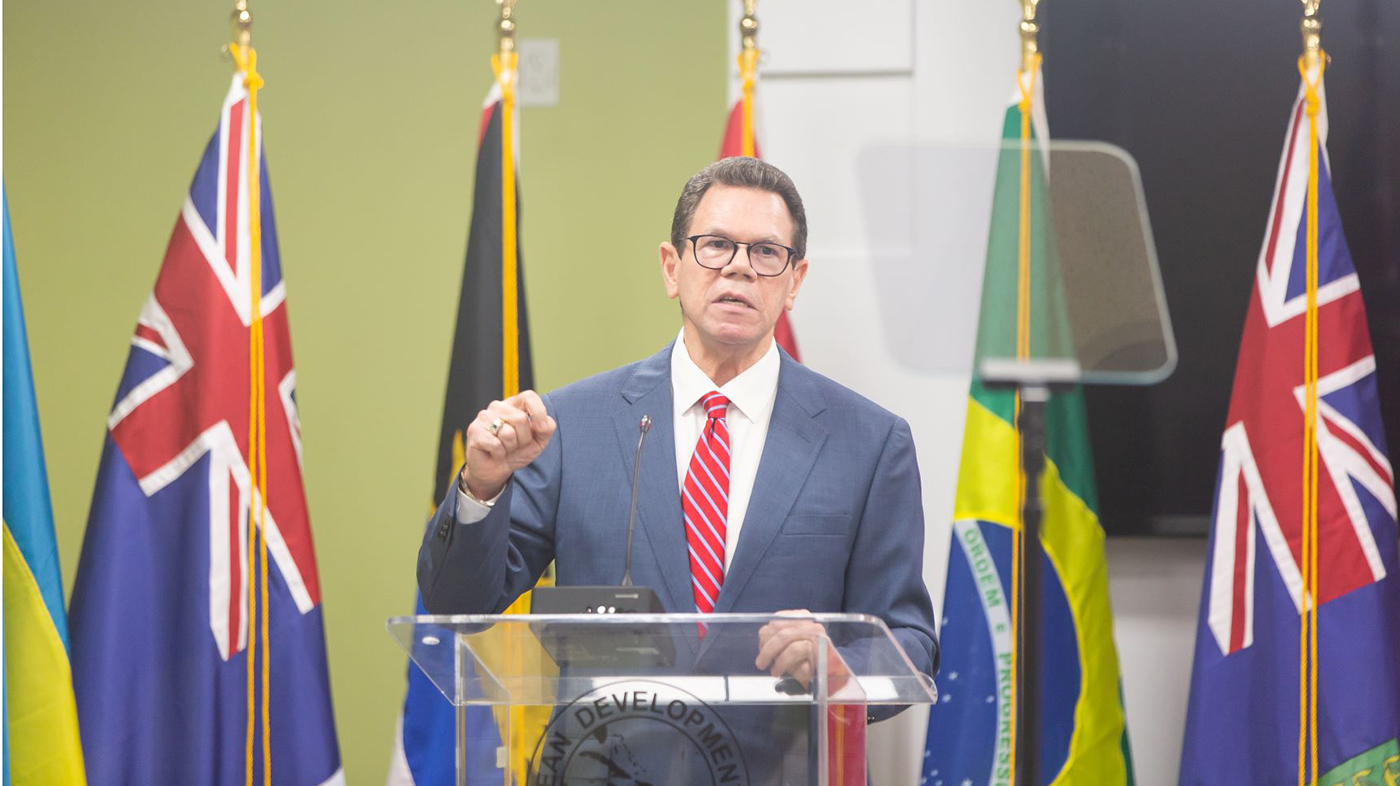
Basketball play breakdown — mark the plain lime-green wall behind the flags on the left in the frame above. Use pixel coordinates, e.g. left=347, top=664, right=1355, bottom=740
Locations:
left=4, top=0, right=725, bottom=783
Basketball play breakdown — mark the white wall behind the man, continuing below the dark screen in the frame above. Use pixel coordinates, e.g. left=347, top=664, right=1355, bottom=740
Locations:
left=725, top=0, right=1204, bottom=786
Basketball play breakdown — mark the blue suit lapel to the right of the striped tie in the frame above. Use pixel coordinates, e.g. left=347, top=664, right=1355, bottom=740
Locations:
left=716, top=352, right=827, bottom=612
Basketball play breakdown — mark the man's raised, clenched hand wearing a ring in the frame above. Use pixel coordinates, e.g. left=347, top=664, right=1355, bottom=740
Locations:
left=462, top=391, right=556, bottom=500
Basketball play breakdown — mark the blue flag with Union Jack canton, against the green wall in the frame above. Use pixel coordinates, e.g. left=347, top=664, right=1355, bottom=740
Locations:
left=71, top=74, right=344, bottom=786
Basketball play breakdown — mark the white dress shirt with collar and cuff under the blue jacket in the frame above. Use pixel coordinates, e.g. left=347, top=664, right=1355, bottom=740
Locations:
left=456, top=328, right=781, bottom=572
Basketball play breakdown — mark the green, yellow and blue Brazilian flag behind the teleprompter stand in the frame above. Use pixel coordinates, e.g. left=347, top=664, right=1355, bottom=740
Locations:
left=923, top=69, right=1131, bottom=786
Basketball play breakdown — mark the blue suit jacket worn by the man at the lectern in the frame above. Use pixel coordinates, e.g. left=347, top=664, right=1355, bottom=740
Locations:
left=419, top=346, right=938, bottom=674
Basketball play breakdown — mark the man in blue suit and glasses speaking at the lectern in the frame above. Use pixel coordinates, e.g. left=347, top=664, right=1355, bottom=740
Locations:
left=419, top=157, right=938, bottom=684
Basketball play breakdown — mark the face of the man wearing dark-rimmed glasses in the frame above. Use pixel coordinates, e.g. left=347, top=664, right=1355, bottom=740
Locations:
left=661, top=184, right=806, bottom=349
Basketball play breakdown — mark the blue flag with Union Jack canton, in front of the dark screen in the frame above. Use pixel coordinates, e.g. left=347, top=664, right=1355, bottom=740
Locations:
left=1180, top=74, right=1400, bottom=786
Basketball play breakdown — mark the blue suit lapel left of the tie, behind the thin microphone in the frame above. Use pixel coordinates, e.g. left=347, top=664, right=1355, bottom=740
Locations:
left=615, top=346, right=696, bottom=612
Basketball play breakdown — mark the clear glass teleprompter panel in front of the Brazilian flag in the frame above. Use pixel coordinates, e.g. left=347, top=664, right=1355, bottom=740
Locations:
left=848, top=140, right=1176, bottom=384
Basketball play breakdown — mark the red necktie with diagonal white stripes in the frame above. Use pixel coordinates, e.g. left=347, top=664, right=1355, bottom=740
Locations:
left=680, top=392, right=729, bottom=614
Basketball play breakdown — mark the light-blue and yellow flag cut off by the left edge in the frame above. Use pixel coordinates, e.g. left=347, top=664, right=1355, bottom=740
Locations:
left=3, top=190, right=85, bottom=786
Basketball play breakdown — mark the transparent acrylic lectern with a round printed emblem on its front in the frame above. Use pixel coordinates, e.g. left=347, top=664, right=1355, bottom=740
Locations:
left=388, top=614, right=935, bottom=786
